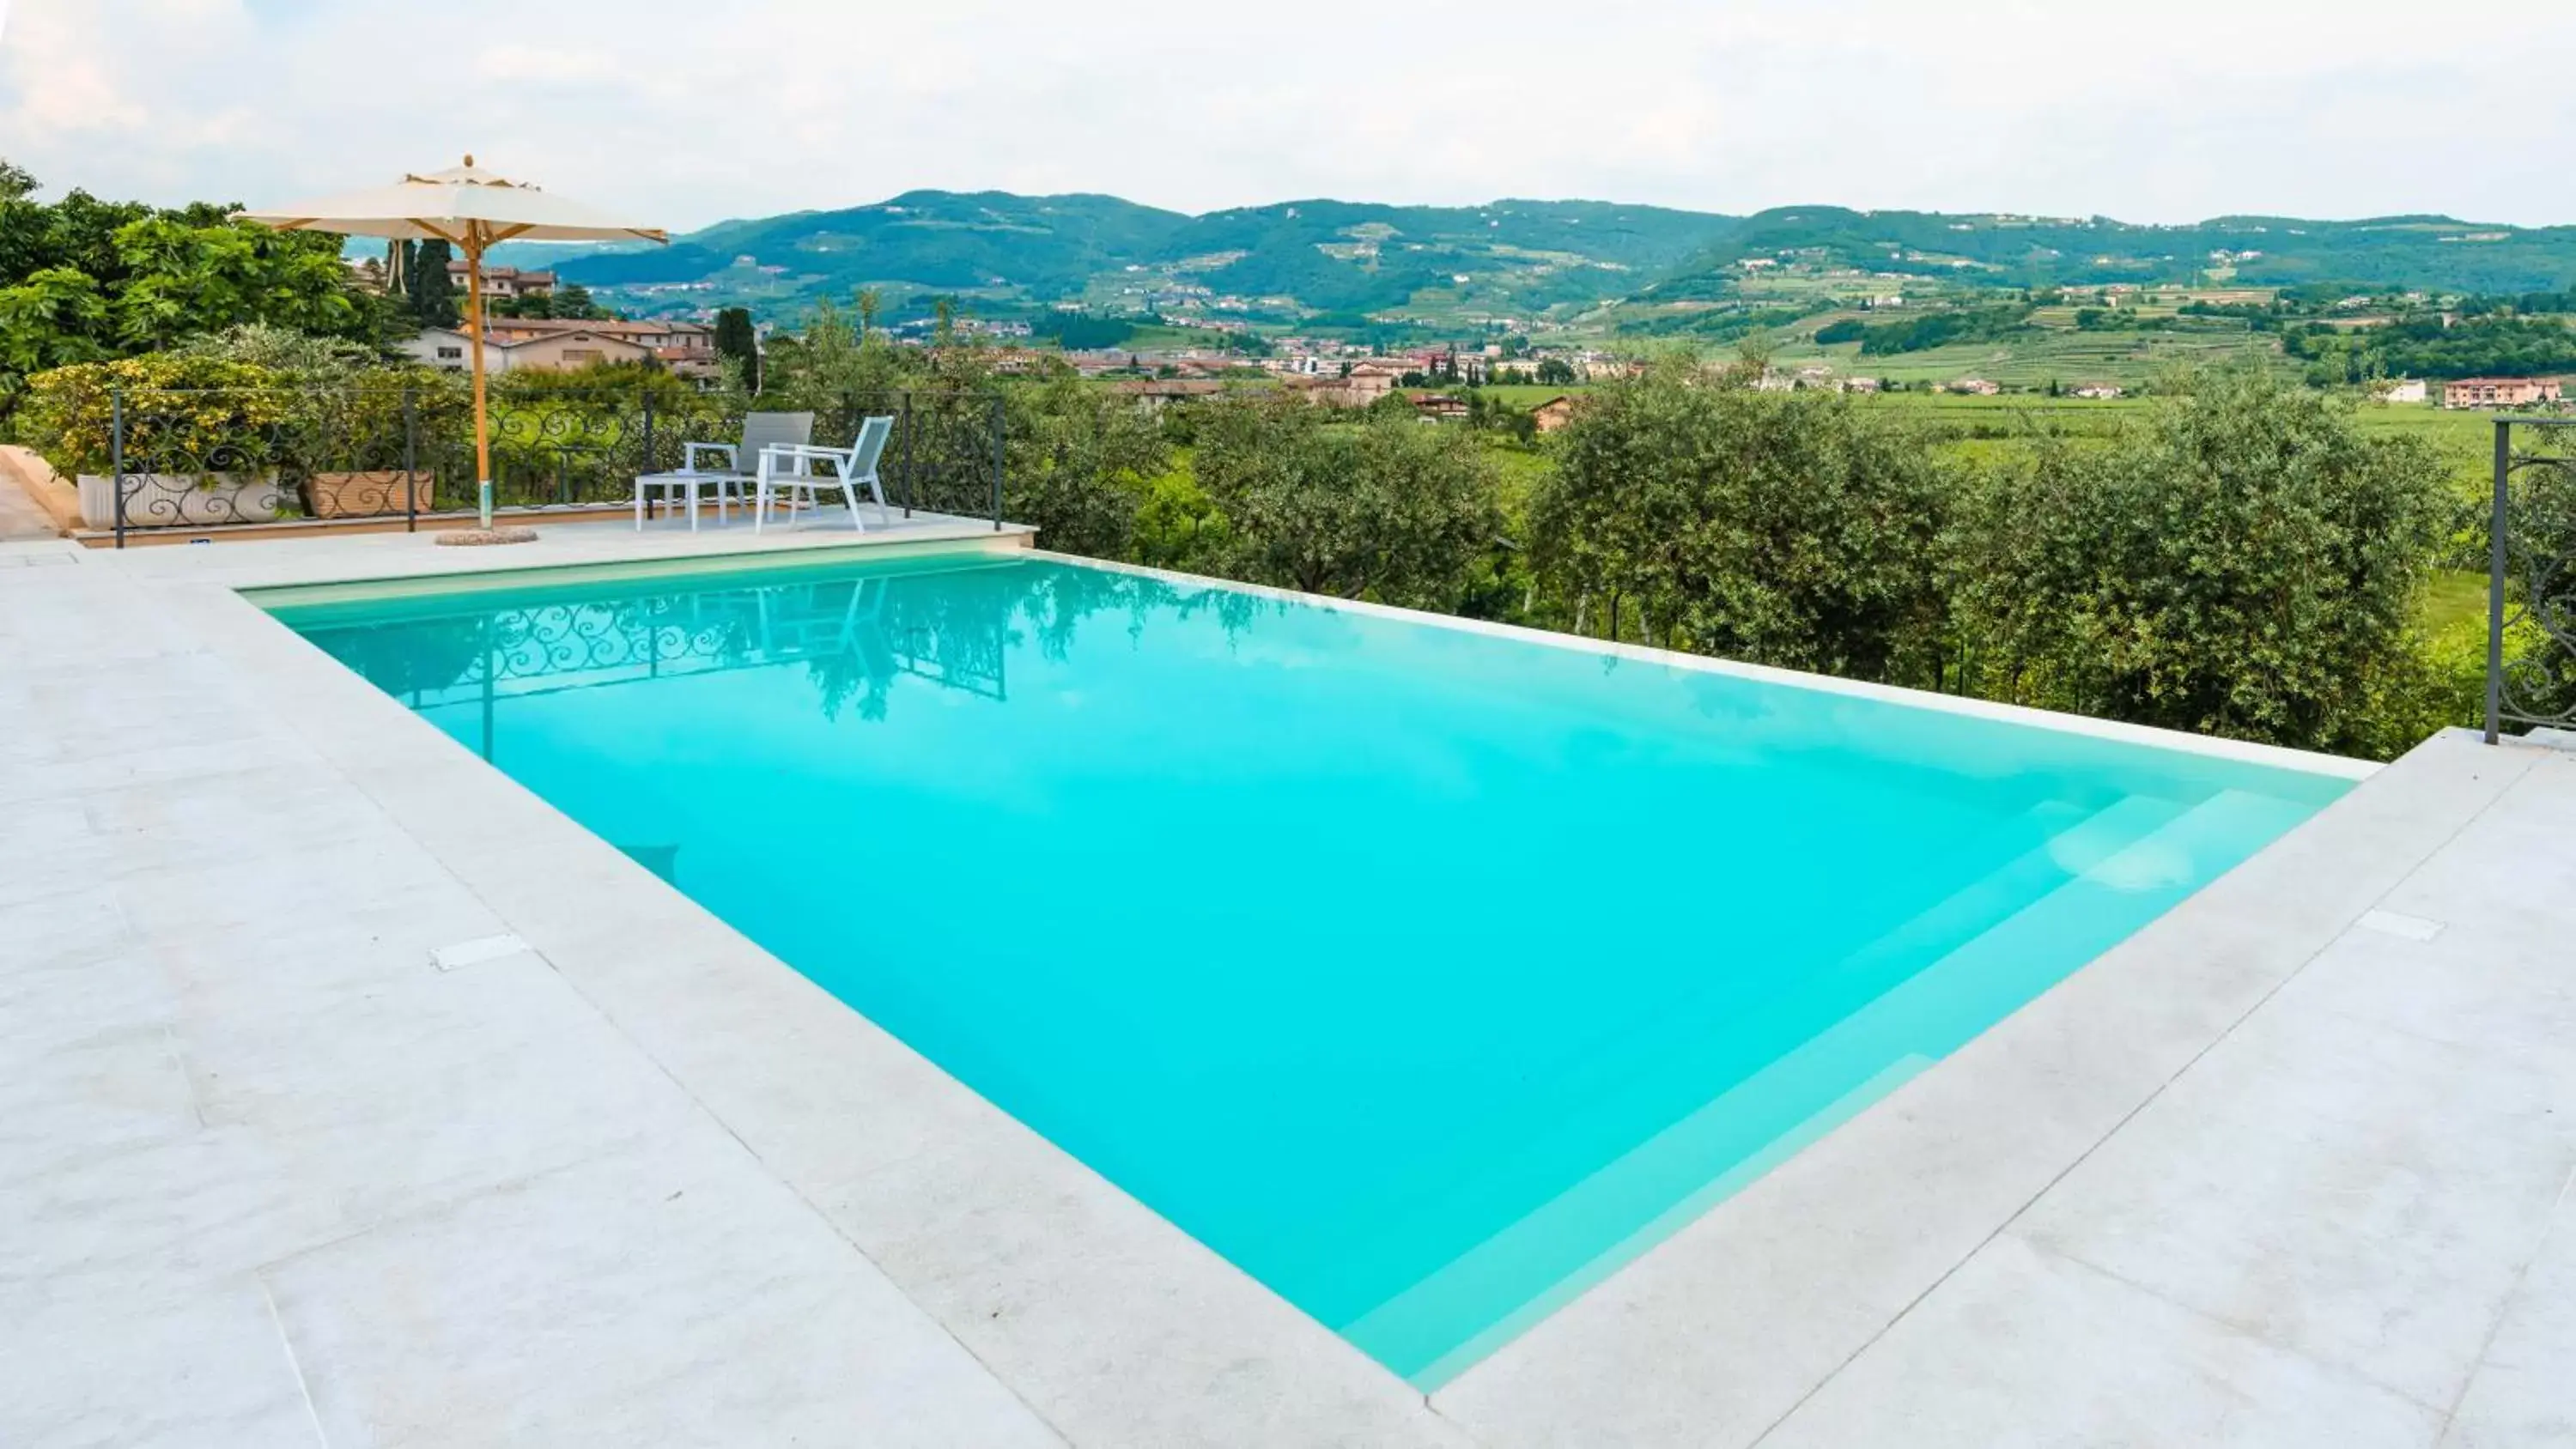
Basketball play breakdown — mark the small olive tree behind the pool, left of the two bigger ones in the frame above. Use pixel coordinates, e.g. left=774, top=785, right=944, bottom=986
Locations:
left=1193, top=399, right=1502, bottom=610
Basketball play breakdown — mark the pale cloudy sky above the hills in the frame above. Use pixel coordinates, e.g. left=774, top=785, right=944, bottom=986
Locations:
left=15, top=0, right=2576, bottom=229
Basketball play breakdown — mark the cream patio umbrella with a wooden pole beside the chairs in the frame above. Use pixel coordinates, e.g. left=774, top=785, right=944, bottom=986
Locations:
left=234, top=157, right=670, bottom=533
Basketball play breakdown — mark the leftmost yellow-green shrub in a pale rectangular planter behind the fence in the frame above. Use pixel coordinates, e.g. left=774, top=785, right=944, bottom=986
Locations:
left=26, top=353, right=289, bottom=528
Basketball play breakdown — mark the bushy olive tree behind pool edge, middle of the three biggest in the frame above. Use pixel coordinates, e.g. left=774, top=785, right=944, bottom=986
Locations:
left=1530, top=361, right=1953, bottom=685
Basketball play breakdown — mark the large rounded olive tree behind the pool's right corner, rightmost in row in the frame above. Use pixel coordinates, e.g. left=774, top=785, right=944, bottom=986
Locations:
left=1958, top=368, right=2445, bottom=754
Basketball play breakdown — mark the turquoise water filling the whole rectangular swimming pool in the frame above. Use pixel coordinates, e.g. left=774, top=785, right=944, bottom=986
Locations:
left=273, top=556, right=2349, bottom=1387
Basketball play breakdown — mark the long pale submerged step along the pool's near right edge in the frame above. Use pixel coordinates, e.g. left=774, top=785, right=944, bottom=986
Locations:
left=1340, top=790, right=2306, bottom=1390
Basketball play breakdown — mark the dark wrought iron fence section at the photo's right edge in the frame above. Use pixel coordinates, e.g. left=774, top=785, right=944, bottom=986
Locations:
left=2486, top=417, right=2576, bottom=743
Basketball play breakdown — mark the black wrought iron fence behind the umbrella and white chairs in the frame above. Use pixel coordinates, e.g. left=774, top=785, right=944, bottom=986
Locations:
left=80, top=386, right=1005, bottom=549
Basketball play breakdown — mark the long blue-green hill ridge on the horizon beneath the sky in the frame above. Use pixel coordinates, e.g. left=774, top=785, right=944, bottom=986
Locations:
left=520, top=191, right=2576, bottom=327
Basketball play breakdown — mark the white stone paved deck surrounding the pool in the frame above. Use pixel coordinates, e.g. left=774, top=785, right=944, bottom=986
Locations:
left=0, top=520, right=2576, bottom=1449
